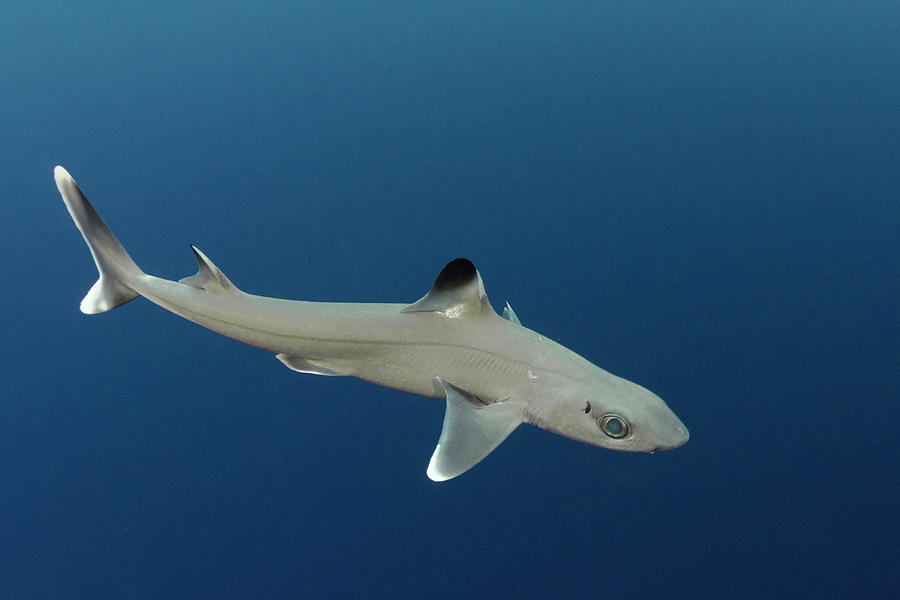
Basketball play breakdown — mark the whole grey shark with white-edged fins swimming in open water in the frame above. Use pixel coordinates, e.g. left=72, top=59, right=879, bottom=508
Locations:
left=54, top=166, right=689, bottom=481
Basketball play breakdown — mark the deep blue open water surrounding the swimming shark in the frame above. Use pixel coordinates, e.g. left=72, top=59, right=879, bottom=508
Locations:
left=0, top=0, right=900, bottom=598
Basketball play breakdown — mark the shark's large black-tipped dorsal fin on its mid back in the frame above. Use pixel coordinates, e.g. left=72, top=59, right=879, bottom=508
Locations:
left=400, top=258, right=493, bottom=318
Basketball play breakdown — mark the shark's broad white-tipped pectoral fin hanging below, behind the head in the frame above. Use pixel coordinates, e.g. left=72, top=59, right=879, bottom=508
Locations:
left=427, top=377, right=522, bottom=481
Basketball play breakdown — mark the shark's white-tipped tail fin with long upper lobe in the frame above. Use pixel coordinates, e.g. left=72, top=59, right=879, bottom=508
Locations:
left=53, top=166, right=144, bottom=315
